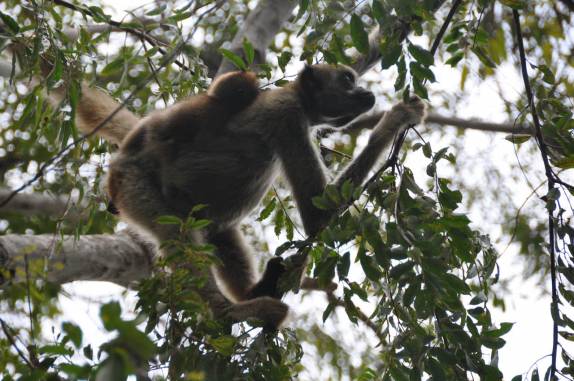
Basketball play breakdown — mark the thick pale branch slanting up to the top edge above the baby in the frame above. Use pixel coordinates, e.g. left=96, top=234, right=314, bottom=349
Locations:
left=217, top=0, right=298, bottom=75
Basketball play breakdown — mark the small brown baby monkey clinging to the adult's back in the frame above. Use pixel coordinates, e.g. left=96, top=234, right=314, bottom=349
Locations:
left=108, top=71, right=259, bottom=212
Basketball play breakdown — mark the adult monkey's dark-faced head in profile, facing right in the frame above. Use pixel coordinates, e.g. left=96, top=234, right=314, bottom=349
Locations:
left=296, top=65, right=375, bottom=126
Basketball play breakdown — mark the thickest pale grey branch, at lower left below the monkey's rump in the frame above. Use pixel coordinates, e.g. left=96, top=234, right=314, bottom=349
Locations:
left=0, top=233, right=155, bottom=286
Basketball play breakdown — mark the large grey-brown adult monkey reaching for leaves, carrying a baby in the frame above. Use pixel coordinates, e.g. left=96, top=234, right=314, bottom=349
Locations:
left=66, top=65, right=425, bottom=327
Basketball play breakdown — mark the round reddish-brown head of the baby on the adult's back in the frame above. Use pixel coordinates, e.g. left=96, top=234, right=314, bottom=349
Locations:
left=207, top=71, right=259, bottom=111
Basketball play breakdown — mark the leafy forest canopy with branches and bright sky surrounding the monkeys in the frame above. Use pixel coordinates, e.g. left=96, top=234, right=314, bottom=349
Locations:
left=0, top=0, right=574, bottom=381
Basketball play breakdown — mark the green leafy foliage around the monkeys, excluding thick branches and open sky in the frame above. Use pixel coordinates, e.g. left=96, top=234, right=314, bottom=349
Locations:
left=0, top=0, right=574, bottom=381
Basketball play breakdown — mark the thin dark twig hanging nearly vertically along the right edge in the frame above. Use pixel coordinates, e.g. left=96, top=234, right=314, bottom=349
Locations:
left=512, top=10, right=559, bottom=380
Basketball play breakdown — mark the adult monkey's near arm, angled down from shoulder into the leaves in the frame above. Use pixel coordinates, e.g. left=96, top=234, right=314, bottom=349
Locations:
left=277, top=124, right=329, bottom=235
